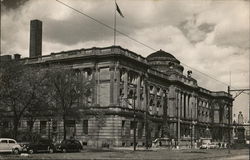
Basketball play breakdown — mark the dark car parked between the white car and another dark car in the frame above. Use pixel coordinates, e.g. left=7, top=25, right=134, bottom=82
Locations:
left=23, top=139, right=55, bottom=154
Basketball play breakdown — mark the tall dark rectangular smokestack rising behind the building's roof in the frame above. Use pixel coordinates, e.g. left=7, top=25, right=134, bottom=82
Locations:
left=30, top=19, right=42, bottom=58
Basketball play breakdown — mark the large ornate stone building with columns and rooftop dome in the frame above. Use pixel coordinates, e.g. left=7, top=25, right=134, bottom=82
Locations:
left=0, top=46, right=233, bottom=146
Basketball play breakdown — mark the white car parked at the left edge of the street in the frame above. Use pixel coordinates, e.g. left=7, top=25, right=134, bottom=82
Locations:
left=0, top=138, right=22, bottom=154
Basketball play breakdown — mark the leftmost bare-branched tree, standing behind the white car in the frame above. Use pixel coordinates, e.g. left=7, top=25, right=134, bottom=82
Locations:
left=0, top=61, right=46, bottom=138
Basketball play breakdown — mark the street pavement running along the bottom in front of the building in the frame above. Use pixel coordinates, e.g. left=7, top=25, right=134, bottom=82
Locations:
left=0, top=148, right=249, bottom=160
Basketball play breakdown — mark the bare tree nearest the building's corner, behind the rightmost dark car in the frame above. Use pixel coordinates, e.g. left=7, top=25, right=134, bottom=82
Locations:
left=47, top=66, right=92, bottom=139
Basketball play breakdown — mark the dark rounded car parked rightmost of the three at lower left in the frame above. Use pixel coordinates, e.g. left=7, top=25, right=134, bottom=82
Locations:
left=55, top=139, right=82, bottom=152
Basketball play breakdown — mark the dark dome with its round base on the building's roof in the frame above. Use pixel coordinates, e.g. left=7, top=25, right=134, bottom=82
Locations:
left=147, top=50, right=184, bottom=74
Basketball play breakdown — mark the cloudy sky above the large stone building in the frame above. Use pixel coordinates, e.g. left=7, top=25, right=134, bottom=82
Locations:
left=1, top=0, right=250, bottom=119
